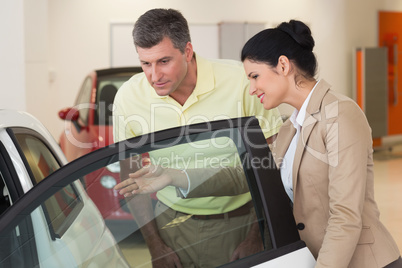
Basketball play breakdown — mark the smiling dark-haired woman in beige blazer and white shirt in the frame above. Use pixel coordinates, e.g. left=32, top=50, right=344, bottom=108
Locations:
left=241, top=20, right=402, bottom=268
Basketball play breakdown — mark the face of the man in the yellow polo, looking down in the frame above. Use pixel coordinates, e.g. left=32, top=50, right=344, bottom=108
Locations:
left=137, top=37, right=193, bottom=96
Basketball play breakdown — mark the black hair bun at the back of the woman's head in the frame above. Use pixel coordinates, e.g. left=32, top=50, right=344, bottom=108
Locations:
left=277, top=20, right=315, bottom=51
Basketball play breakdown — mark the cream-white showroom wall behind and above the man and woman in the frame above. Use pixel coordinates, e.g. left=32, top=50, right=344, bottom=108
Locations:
left=0, top=0, right=401, bottom=138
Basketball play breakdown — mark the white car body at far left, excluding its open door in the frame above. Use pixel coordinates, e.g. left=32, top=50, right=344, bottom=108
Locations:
left=0, top=110, right=129, bottom=267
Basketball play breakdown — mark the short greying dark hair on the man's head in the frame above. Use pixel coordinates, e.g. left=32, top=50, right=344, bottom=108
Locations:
left=133, top=8, right=191, bottom=53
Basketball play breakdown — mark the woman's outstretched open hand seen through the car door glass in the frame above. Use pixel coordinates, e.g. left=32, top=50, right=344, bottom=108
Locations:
left=114, top=161, right=188, bottom=197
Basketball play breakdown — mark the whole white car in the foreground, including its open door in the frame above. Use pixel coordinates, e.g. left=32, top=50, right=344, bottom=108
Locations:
left=0, top=111, right=315, bottom=268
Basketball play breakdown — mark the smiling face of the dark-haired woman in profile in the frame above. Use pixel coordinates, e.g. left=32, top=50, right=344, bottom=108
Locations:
left=243, top=60, right=289, bottom=110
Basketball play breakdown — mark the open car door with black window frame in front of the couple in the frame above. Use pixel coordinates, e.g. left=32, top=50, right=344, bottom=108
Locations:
left=0, top=117, right=315, bottom=267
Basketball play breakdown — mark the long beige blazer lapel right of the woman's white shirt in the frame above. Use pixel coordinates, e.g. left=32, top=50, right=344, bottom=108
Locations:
left=285, top=80, right=330, bottom=197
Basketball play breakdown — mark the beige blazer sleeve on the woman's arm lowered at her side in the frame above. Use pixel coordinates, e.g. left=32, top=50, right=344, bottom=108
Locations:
left=317, top=101, right=372, bottom=267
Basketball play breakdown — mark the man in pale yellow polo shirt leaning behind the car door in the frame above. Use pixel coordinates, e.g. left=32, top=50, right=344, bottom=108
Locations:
left=113, top=9, right=282, bottom=267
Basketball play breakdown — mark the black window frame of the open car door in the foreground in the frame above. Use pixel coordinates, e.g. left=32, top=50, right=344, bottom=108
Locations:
left=0, top=117, right=305, bottom=267
